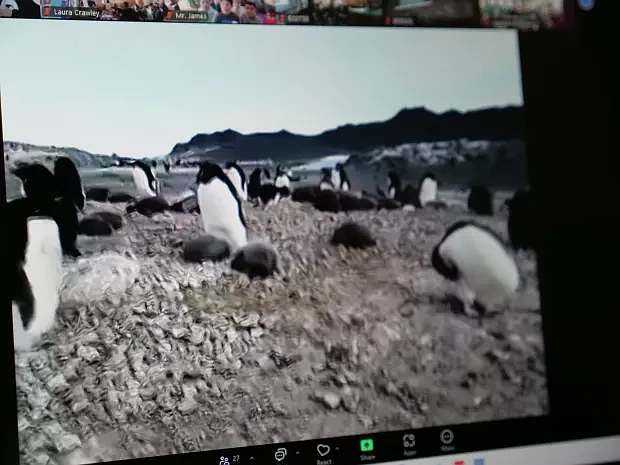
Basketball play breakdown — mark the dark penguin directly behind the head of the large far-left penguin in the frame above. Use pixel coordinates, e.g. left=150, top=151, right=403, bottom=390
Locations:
left=13, top=163, right=82, bottom=258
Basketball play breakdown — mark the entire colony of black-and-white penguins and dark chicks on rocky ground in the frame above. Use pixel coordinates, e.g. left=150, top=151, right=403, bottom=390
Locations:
left=7, top=157, right=536, bottom=350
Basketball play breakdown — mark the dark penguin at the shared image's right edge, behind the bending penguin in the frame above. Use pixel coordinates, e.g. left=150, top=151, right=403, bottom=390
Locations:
left=506, top=189, right=536, bottom=250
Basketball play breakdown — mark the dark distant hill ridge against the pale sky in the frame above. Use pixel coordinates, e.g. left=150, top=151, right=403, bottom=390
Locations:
left=169, top=106, right=524, bottom=162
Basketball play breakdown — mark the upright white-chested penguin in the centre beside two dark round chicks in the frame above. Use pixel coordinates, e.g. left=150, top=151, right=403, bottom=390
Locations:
left=196, top=161, right=247, bottom=251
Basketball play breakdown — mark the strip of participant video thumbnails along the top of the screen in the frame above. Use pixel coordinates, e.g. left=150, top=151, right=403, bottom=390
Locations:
left=0, top=0, right=575, bottom=31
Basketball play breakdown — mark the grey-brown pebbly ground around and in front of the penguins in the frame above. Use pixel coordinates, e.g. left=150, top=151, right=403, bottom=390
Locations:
left=16, top=191, right=547, bottom=465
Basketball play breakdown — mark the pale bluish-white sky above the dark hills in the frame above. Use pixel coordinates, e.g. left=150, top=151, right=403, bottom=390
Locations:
left=0, top=19, right=523, bottom=157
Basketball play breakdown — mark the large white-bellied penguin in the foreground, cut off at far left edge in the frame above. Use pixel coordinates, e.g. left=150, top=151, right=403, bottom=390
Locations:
left=6, top=198, right=63, bottom=351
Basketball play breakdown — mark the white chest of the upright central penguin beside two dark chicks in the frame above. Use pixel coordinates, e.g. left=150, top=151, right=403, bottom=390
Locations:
left=197, top=179, right=247, bottom=249
